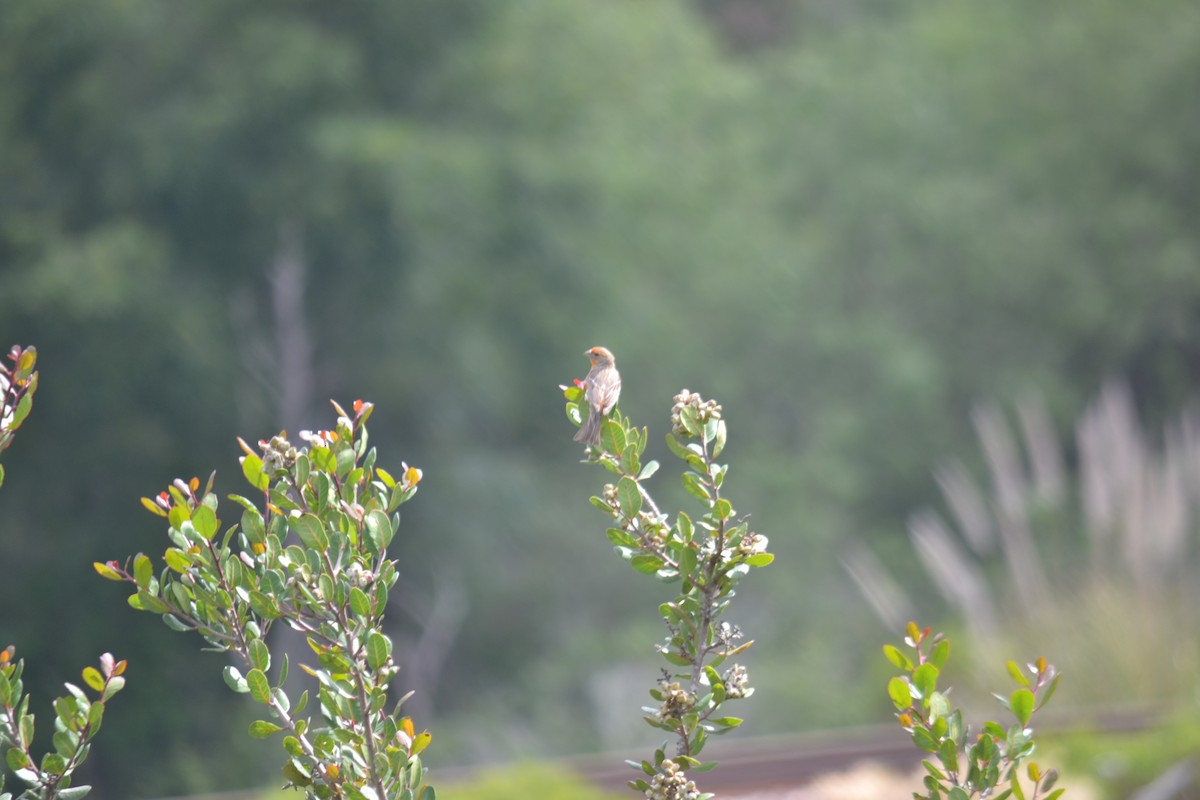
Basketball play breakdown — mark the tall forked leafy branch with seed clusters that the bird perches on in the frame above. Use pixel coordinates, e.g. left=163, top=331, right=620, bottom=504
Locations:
left=562, top=386, right=774, bottom=798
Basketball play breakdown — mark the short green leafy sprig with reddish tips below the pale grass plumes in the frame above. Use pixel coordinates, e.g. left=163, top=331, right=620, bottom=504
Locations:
left=883, top=622, right=1066, bottom=800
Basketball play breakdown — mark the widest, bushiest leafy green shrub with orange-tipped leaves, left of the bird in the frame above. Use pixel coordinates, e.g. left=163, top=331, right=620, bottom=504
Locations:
left=95, top=401, right=434, bottom=800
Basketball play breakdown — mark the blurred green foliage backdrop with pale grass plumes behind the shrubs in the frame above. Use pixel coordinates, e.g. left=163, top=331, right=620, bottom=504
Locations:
left=0, top=0, right=1200, bottom=800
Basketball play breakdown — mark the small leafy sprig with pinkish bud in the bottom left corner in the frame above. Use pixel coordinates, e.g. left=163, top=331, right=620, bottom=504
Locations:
left=0, top=645, right=125, bottom=800
